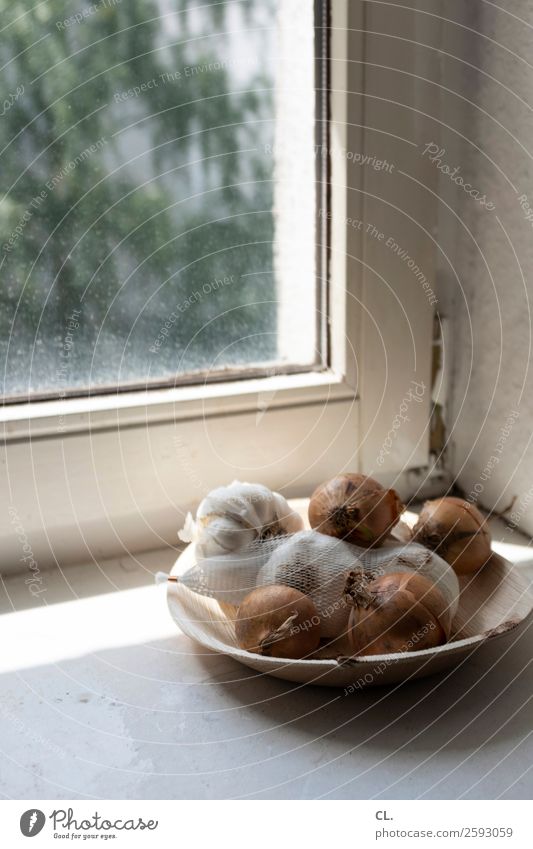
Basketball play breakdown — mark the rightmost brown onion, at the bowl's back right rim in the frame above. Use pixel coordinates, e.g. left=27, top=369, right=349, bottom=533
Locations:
left=412, top=497, right=492, bottom=575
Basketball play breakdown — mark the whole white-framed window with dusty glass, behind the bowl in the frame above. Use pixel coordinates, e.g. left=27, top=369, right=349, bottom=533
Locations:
left=0, top=0, right=433, bottom=571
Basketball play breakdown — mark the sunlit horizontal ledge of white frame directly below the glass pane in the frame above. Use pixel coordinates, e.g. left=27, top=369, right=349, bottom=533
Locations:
left=0, top=370, right=356, bottom=440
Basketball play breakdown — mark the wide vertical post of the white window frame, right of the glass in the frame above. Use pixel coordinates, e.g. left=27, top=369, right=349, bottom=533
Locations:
left=342, top=0, right=439, bottom=476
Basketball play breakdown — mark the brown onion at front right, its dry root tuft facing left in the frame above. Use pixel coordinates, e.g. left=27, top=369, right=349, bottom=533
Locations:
left=346, top=572, right=449, bottom=655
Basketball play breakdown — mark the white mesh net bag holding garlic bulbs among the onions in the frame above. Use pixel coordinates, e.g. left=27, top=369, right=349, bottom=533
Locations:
left=179, top=531, right=459, bottom=638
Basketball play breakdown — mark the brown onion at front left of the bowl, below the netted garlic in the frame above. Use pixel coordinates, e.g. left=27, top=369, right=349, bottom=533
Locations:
left=235, top=585, right=320, bottom=658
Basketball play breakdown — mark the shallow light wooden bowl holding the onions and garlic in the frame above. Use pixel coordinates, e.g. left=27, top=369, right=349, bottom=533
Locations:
left=167, top=545, right=532, bottom=692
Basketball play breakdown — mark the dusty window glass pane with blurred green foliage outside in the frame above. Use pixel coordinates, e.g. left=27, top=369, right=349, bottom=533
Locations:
left=0, top=0, right=318, bottom=396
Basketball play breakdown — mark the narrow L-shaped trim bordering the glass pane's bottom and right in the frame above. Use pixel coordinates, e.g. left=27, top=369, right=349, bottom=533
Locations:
left=0, top=0, right=356, bottom=441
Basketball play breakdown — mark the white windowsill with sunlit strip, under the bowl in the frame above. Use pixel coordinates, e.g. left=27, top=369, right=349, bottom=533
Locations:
left=0, top=500, right=532, bottom=799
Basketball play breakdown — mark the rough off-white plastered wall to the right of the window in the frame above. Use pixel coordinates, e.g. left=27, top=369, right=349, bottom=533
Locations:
left=427, top=0, right=533, bottom=534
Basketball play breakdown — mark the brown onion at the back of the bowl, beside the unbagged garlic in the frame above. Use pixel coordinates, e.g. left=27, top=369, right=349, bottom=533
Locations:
left=309, top=474, right=404, bottom=548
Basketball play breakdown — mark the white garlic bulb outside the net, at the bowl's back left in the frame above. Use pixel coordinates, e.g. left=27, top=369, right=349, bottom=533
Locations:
left=180, top=481, right=303, bottom=558
